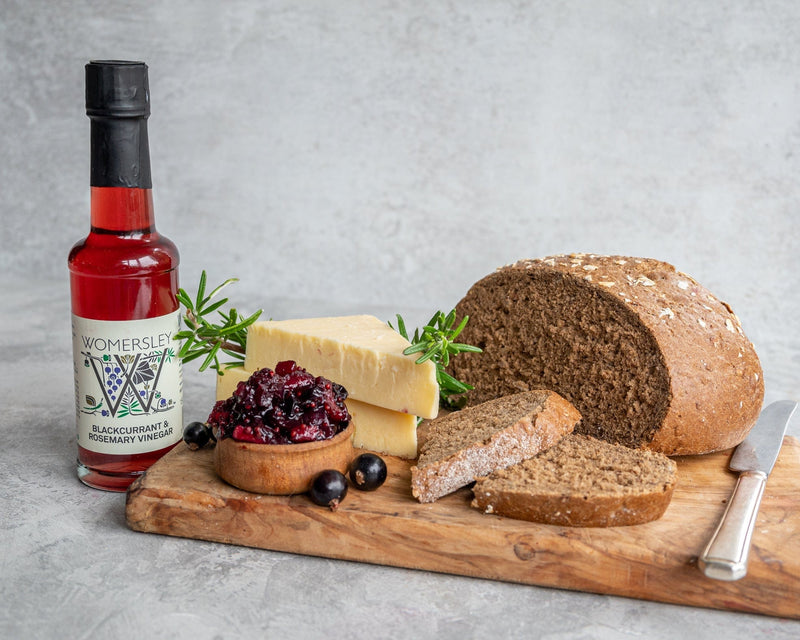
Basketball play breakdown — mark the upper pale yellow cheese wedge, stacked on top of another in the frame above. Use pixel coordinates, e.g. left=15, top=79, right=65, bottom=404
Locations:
left=244, top=316, right=439, bottom=418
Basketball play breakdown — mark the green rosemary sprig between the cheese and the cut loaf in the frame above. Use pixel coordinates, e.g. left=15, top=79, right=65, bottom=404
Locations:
left=388, top=309, right=482, bottom=409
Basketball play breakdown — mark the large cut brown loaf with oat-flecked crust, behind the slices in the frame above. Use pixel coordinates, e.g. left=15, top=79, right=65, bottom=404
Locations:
left=450, top=254, right=764, bottom=455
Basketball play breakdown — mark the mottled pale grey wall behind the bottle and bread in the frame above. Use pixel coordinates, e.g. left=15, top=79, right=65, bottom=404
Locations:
left=0, top=0, right=800, bottom=402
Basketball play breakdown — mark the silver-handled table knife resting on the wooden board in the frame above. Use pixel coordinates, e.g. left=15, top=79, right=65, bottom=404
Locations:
left=697, top=400, right=797, bottom=581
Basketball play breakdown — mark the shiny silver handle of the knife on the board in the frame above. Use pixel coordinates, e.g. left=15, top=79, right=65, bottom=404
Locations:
left=697, top=471, right=767, bottom=581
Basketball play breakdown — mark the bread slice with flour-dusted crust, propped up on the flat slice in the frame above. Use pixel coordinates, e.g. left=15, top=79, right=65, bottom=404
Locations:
left=411, top=390, right=580, bottom=502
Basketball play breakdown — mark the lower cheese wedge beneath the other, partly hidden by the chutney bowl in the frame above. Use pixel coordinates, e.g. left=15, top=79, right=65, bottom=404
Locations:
left=217, top=367, right=417, bottom=459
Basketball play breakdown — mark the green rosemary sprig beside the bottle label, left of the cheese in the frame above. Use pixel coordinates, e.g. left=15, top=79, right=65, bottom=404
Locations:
left=175, top=271, right=261, bottom=375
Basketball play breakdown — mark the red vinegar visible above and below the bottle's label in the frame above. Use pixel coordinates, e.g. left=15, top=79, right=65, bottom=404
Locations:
left=68, top=187, right=179, bottom=491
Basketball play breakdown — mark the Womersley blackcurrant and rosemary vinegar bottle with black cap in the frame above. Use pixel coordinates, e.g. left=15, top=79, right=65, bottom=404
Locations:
left=68, top=61, right=183, bottom=491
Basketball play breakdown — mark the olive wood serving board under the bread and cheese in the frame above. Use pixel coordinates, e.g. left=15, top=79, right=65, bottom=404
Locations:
left=126, top=436, right=800, bottom=618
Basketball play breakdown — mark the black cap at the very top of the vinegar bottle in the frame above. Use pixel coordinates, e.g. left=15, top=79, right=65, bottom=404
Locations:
left=86, top=60, right=150, bottom=118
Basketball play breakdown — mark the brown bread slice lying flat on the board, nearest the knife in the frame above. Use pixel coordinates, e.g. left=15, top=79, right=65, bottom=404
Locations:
left=472, top=434, right=676, bottom=527
